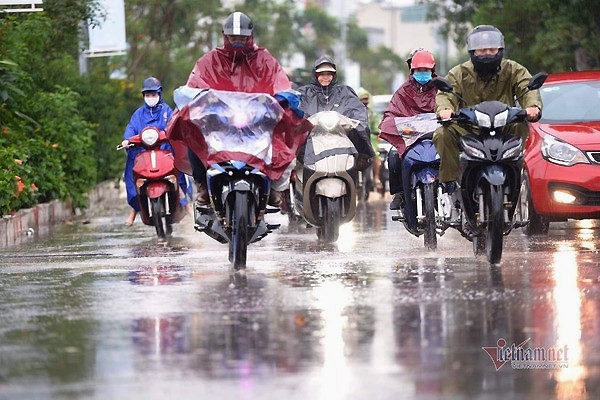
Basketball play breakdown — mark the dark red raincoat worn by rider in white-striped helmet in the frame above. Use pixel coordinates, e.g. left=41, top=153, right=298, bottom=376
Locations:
left=167, top=35, right=312, bottom=180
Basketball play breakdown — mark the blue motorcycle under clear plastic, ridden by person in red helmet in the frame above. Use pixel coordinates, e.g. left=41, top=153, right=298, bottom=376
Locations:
left=392, top=113, right=451, bottom=250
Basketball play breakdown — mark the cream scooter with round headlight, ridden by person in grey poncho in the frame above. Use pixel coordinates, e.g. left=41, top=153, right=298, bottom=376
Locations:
left=291, top=111, right=359, bottom=242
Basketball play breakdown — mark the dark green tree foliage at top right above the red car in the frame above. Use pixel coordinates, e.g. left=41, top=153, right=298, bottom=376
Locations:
left=427, top=0, right=600, bottom=72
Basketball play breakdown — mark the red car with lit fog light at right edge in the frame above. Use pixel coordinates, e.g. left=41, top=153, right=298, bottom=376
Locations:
left=520, top=71, right=600, bottom=234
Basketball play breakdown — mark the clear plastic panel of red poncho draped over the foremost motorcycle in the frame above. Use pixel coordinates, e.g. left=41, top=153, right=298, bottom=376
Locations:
left=189, top=90, right=283, bottom=165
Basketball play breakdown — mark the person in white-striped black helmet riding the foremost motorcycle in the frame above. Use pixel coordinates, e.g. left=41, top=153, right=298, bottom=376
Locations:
left=168, top=12, right=300, bottom=207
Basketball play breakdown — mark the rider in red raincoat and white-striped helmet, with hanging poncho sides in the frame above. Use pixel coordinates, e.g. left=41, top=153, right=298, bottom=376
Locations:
left=167, top=12, right=312, bottom=206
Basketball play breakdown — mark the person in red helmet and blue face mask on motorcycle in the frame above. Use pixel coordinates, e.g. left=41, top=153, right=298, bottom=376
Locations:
left=379, top=48, right=437, bottom=210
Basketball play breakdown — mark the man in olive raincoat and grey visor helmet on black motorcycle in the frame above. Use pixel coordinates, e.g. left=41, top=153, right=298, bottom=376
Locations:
left=433, top=25, right=542, bottom=198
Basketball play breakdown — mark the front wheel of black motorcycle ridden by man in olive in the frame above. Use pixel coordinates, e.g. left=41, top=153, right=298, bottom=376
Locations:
left=484, top=185, right=504, bottom=264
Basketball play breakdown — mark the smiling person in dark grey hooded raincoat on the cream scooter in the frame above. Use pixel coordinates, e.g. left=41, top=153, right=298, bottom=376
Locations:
left=298, top=55, right=375, bottom=171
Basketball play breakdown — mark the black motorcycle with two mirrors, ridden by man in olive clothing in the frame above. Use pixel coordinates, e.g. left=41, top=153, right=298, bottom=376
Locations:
left=433, top=73, right=548, bottom=264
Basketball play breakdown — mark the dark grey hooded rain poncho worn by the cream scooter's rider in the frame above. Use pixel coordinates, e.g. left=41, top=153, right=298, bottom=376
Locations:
left=298, top=56, right=375, bottom=157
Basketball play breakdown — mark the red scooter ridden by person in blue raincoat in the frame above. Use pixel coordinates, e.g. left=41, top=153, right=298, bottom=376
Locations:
left=117, top=126, right=185, bottom=239
